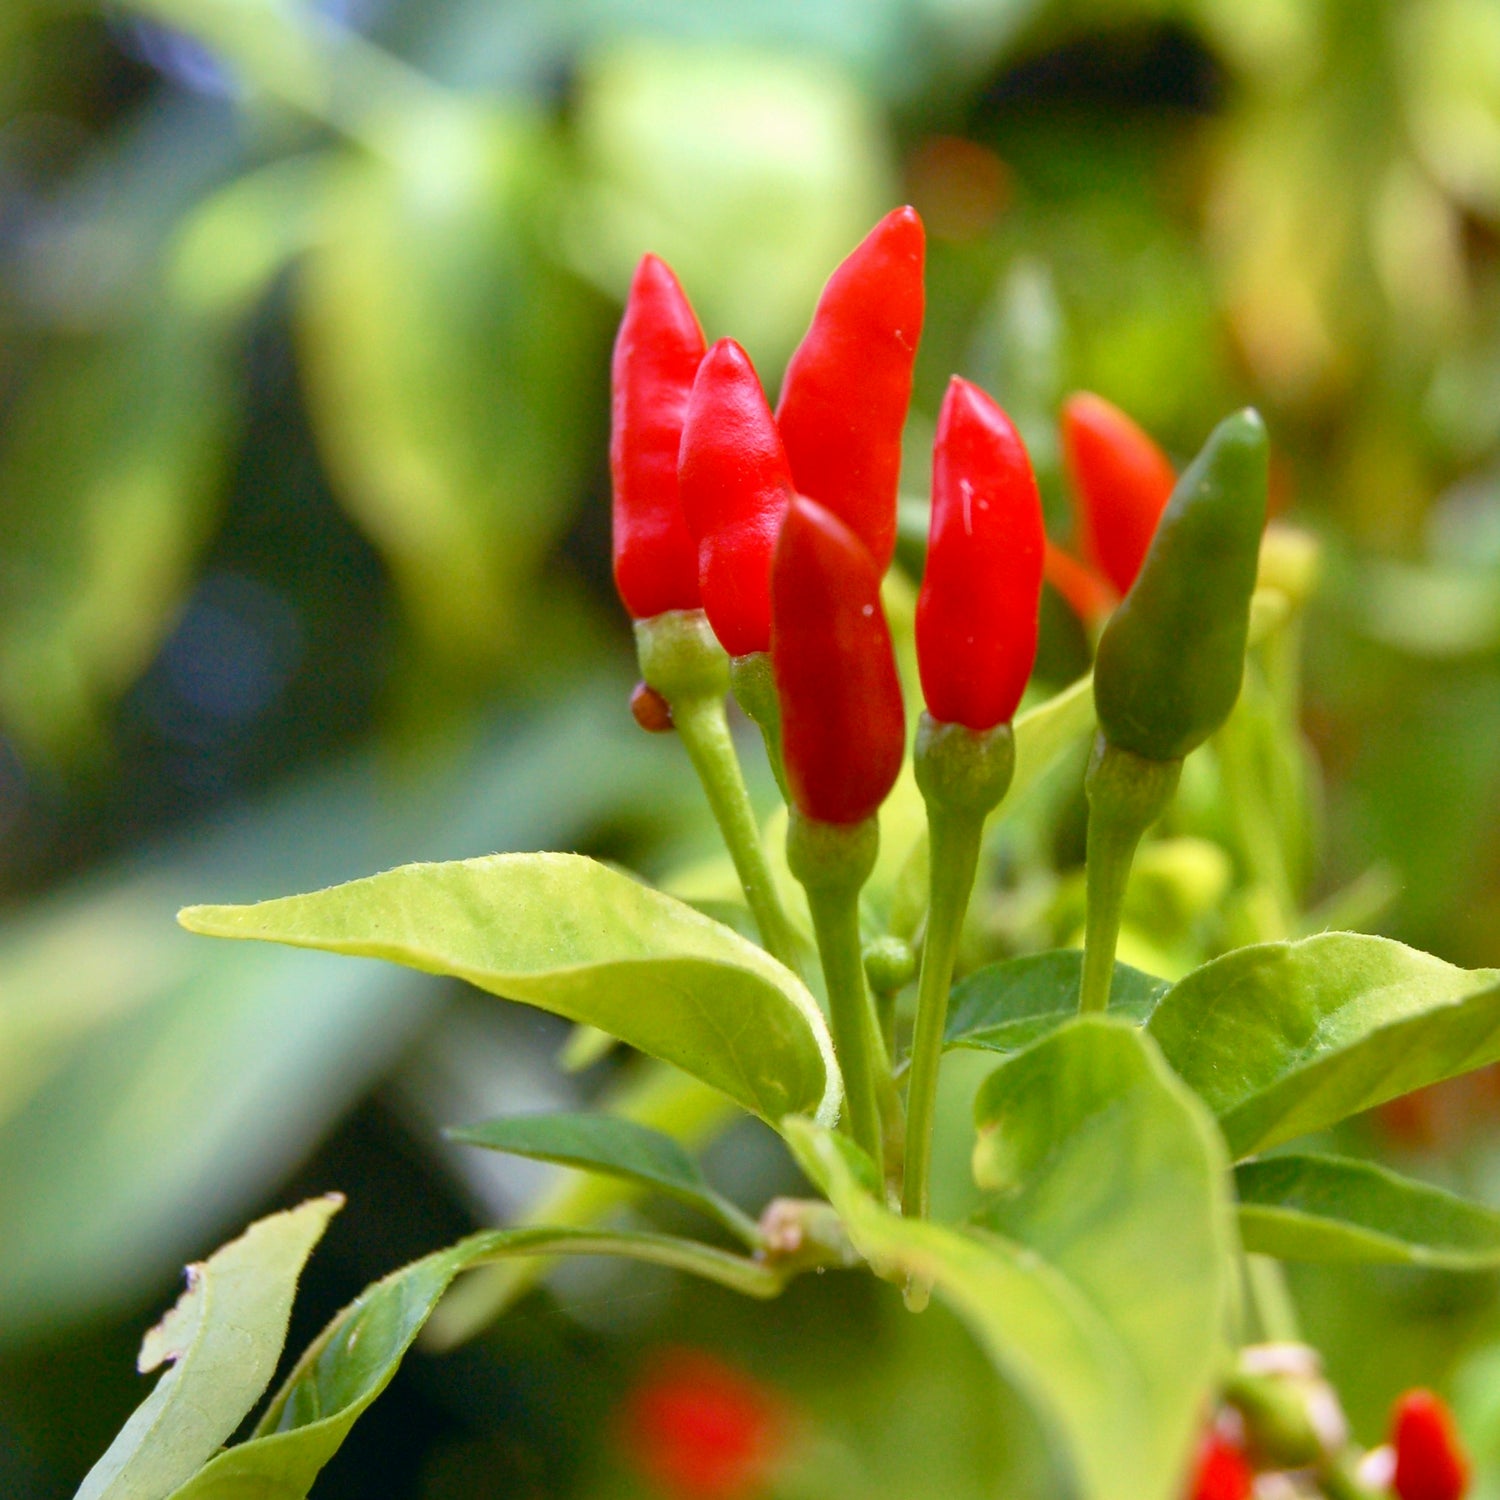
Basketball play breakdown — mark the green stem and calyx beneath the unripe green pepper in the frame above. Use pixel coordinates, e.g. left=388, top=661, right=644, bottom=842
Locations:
left=1079, top=735, right=1182, bottom=1016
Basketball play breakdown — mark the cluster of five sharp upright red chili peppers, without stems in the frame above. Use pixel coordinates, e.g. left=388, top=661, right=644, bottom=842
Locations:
left=611, top=209, right=1056, bottom=824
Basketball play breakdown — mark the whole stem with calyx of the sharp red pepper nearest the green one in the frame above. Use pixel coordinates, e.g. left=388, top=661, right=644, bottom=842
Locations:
left=902, top=714, right=1016, bottom=1218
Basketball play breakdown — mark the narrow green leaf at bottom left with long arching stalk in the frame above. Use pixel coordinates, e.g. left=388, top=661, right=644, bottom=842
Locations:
left=171, top=1229, right=783, bottom=1500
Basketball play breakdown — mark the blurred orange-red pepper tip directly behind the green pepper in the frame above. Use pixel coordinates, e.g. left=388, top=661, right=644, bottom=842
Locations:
left=1062, top=392, right=1178, bottom=596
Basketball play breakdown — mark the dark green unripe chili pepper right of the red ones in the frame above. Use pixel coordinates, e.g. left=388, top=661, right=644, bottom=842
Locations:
left=1094, top=410, right=1268, bottom=761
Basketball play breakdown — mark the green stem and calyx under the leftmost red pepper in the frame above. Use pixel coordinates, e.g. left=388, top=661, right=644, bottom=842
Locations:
left=636, top=609, right=801, bottom=974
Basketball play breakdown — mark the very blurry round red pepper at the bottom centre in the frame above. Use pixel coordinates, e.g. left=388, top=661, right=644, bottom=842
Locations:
left=621, top=1349, right=791, bottom=1500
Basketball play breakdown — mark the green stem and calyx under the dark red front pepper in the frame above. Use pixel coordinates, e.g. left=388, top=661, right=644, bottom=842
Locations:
left=786, top=809, right=891, bottom=1182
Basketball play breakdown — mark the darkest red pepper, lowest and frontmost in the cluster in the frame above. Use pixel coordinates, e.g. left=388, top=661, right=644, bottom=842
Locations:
left=771, top=495, right=906, bottom=824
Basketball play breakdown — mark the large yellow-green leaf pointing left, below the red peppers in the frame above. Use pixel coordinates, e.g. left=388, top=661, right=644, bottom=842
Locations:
left=180, top=854, right=840, bottom=1124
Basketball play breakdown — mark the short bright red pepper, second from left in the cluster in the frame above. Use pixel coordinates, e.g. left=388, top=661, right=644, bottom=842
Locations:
left=678, top=339, right=792, bottom=657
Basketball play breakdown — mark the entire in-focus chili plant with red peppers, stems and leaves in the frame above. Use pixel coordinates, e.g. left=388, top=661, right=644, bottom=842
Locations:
left=80, top=209, right=1500, bottom=1500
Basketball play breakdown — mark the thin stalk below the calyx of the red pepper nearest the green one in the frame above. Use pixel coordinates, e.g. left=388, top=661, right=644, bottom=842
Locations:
left=902, top=809, right=984, bottom=1218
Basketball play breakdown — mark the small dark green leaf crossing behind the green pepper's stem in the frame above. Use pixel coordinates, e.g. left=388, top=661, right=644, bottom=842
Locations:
left=944, top=948, right=1172, bottom=1052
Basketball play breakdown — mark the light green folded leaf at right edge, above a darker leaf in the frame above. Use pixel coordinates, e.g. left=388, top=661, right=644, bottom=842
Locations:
left=1148, top=933, right=1500, bottom=1158
